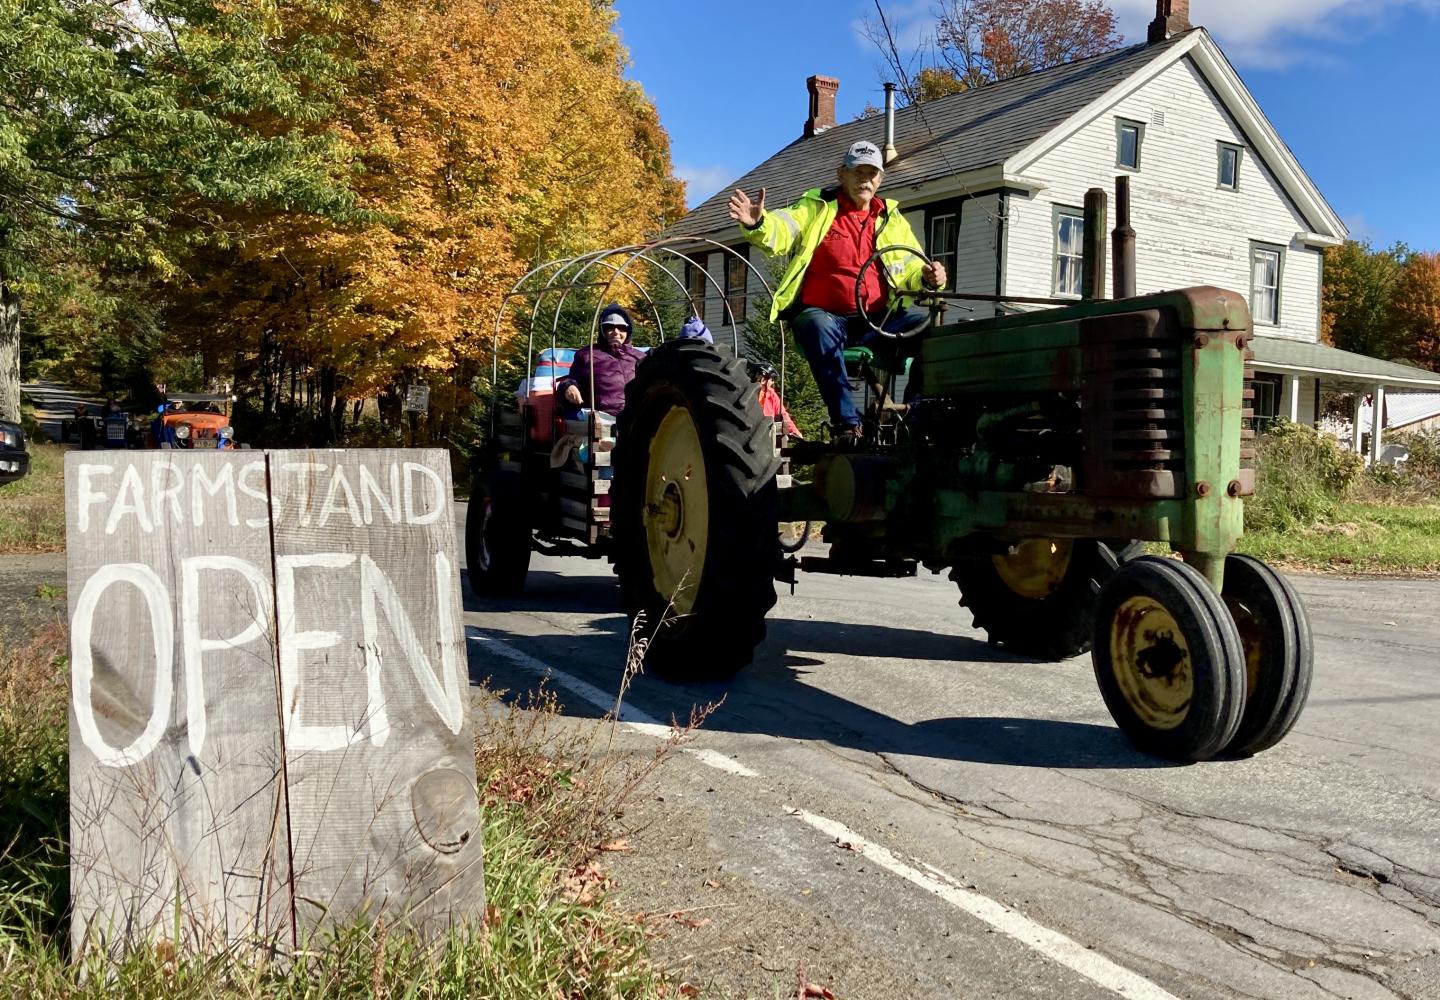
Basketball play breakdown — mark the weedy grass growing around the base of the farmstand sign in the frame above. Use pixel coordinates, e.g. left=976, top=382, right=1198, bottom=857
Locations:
left=0, top=620, right=696, bottom=1000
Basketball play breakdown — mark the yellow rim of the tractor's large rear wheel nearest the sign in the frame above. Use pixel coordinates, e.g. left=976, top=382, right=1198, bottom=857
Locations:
left=645, top=406, right=710, bottom=614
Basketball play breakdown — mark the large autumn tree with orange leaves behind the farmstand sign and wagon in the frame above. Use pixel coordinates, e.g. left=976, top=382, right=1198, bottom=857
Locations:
left=171, top=0, right=684, bottom=441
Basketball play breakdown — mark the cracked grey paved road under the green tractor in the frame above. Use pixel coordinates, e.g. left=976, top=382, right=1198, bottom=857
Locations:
left=467, top=510, right=1440, bottom=1000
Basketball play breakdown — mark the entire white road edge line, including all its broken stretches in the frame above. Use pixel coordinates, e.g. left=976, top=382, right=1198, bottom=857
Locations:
left=467, top=627, right=1179, bottom=1000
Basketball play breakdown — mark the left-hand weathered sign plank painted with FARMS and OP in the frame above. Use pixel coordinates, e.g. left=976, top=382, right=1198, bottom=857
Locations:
left=65, top=451, right=289, bottom=951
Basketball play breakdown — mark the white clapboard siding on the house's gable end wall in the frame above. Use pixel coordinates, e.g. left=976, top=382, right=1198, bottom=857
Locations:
left=1005, top=58, right=1320, bottom=340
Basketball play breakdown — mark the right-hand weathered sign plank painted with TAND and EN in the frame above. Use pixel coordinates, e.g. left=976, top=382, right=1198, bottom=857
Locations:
left=271, top=451, right=484, bottom=928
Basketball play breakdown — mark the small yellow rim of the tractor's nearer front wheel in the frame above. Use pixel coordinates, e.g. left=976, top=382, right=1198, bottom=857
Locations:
left=1110, top=595, right=1195, bottom=729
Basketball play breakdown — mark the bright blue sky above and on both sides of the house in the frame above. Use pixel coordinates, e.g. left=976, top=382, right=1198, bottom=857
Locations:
left=615, top=0, right=1440, bottom=249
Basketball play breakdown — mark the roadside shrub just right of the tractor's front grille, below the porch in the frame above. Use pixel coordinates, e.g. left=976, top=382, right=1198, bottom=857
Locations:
left=1246, top=421, right=1365, bottom=532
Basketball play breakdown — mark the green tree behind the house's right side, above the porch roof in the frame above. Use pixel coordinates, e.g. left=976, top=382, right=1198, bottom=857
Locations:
left=1320, top=239, right=1410, bottom=360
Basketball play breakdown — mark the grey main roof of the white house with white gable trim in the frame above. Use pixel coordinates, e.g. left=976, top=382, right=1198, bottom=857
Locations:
left=664, top=27, right=1345, bottom=244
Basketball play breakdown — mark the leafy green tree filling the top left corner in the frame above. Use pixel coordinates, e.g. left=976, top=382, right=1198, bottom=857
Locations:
left=0, top=0, right=348, bottom=418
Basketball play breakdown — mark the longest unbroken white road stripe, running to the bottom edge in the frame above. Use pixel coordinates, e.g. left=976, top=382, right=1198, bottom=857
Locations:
left=789, top=808, right=1178, bottom=1000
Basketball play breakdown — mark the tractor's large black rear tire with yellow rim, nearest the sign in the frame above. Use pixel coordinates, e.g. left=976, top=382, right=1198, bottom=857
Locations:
left=611, top=340, right=779, bottom=682
